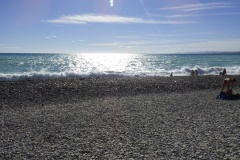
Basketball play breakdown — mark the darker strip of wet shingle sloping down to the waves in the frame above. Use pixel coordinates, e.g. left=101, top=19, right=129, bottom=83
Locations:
left=0, top=76, right=240, bottom=106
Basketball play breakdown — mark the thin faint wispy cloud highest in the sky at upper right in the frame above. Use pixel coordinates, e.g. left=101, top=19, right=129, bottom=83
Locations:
left=161, top=2, right=236, bottom=11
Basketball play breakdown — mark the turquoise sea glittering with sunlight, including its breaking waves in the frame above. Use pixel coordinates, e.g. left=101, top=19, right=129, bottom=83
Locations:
left=0, top=52, right=240, bottom=81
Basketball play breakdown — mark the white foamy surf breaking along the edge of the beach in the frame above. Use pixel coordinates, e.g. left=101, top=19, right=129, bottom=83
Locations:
left=0, top=66, right=240, bottom=81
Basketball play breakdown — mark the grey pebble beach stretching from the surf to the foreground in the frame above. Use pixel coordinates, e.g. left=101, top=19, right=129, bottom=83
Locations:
left=0, top=75, right=240, bottom=160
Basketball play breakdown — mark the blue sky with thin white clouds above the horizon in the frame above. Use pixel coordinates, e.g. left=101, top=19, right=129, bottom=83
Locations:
left=0, top=0, right=240, bottom=53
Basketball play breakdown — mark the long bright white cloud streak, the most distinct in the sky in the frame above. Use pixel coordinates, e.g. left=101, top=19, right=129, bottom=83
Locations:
left=44, top=14, right=195, bottom=24
